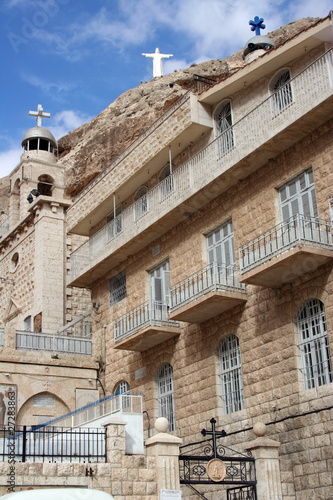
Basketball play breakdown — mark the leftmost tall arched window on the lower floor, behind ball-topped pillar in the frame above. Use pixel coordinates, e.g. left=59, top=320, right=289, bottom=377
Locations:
left=157, top=363, right=176, bottom=431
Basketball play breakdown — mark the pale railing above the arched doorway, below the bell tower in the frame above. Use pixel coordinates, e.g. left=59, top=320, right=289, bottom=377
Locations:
left=16, top=330, right=92, bottom=356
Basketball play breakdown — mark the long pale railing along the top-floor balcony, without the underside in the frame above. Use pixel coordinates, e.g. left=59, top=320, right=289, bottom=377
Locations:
left=70, top=49, right=333, bottom=281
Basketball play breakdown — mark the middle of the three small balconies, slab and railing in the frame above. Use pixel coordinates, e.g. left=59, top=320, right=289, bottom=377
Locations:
left=169, top=263, right=247, bottom=323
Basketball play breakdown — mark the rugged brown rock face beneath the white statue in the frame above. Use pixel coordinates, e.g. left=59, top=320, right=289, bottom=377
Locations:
left=0, top=18, right=319, bottom=201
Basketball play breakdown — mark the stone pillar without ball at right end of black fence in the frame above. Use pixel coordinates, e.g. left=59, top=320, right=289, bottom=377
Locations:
left=104, top=416, right=126, bottom=467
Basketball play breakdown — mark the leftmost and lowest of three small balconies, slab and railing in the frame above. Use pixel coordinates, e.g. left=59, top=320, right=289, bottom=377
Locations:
left=114, top=301, right=180, bottom=351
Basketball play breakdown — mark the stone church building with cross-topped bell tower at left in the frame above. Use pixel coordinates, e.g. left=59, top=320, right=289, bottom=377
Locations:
left=0, top=106, right=99, bottom=425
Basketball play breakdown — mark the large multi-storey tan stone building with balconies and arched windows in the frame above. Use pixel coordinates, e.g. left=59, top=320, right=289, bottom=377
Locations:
left=67, top=13, right=333, bottom=500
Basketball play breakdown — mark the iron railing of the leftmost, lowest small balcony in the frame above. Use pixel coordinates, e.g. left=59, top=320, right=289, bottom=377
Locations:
left=114, top=301, right=179, bottom=342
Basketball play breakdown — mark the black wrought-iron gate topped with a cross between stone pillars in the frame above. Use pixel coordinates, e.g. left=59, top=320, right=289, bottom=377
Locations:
left=179, top=418, right=257, bottom=500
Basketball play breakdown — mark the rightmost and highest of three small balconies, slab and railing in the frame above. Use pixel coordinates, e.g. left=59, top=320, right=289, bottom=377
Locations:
left=239, top=215, right=333, bottom=288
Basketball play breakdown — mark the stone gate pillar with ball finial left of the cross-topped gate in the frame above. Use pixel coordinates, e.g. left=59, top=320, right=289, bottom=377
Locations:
left=145, top=417, right=182, bottom=492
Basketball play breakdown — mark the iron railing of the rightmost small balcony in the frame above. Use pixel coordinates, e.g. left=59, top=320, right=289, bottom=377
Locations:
left=239, top=214, right=332, bottom=273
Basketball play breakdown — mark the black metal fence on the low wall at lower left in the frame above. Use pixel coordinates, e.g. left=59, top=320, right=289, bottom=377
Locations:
left=0, top=426, right=106, bottom=463
